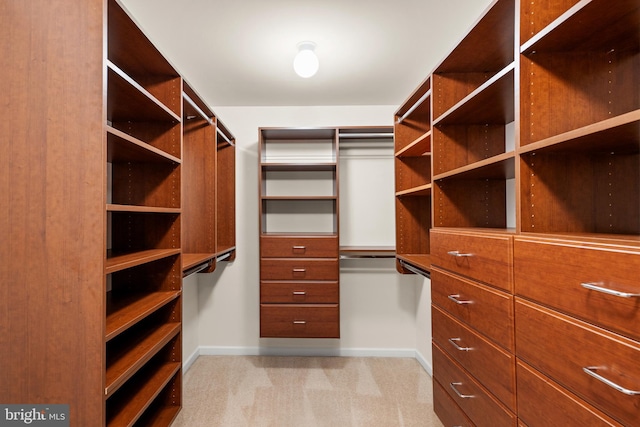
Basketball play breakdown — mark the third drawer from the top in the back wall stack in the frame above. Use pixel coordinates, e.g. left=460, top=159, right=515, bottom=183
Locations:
left=260, top=282, right=340, bottom=304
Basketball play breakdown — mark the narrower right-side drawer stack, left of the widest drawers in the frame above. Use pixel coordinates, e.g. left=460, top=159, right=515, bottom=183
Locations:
left=431, top=228, right=517, bottom=426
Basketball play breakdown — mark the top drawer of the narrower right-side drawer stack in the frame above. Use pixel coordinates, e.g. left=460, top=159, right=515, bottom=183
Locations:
left=430, top=229, right=513, bottom=292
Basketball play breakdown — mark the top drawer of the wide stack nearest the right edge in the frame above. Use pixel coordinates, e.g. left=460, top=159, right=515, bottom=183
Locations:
left=514, top=239, right=640, bottom=339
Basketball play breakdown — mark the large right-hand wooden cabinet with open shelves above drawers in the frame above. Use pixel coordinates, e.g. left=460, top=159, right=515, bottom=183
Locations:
left=396, top=0, right=640, bottom=427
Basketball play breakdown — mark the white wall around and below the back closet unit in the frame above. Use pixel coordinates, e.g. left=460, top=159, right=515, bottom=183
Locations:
left=183, top=106, right=431, bottom=369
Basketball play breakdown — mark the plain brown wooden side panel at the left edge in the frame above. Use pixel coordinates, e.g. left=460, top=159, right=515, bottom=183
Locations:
left=0, top=0, right=105, bottom=426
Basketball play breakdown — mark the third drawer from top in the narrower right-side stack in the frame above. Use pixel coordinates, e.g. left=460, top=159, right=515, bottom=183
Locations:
left=431, top=307, right=516, bottom=412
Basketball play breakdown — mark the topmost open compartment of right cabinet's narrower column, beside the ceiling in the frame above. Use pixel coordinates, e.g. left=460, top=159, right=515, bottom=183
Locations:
left=432, top=0, right=515, bottom=122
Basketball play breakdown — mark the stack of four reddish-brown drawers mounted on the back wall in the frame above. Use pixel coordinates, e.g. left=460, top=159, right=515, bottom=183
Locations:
left=260, top=236, right=340, bottom=338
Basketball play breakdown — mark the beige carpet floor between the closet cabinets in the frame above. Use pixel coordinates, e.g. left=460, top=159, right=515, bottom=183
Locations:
left=172, top=356, right=442, bottom=427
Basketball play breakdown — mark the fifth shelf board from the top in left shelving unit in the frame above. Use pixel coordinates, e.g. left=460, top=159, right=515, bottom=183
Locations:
left=105, top=290, right=180, bottom=341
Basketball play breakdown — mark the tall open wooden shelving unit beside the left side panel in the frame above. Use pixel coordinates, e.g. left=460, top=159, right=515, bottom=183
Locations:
left=104, top=0, right=182, bottom=426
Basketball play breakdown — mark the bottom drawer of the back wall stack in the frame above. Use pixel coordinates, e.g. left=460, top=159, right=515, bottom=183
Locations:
left=260, top=304, right=340, bottom=338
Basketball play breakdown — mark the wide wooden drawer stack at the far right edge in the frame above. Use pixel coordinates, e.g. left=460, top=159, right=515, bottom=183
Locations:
left=514, top=236, right=640, bottom=427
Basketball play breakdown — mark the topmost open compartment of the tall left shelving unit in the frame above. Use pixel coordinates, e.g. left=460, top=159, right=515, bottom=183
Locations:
left=107, top=0, right=182, bottom=117
